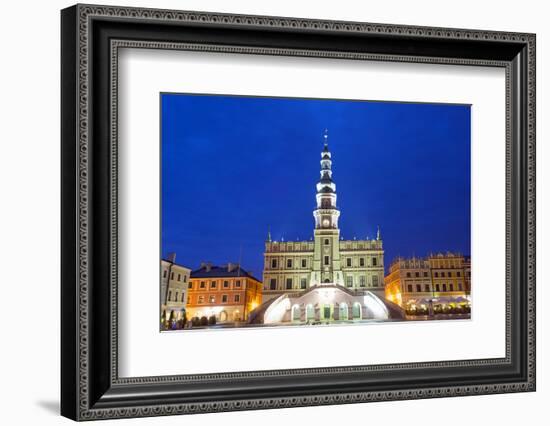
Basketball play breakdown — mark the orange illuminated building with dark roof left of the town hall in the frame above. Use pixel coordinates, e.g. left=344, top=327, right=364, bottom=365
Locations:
left=186, top=263, right=262, bottom=323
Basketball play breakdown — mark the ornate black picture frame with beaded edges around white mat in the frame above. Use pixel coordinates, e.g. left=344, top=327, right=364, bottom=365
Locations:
left=61, top=5, right=535, bottom=420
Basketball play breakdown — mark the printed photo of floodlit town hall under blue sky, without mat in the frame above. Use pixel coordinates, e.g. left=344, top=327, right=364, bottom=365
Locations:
left=159, top=93, right=472, bottom=331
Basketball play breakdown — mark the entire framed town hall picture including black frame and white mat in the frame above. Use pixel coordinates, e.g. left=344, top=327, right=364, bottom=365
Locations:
left=61, top=5, right=535, bottom=420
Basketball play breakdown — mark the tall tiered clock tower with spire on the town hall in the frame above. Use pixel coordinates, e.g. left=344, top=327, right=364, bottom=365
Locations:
left=310, top=129, right=344, bottom=286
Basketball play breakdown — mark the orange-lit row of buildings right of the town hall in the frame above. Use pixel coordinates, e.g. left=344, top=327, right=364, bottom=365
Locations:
left=384, top=253, right=470, bottom=309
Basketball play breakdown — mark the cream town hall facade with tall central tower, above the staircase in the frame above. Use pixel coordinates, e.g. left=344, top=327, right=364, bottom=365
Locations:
left=263, top=131, right=384, bottom=300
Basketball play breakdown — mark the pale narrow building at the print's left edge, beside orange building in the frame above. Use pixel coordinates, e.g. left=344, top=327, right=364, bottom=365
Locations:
left=160, top=255, right=191, bottom=327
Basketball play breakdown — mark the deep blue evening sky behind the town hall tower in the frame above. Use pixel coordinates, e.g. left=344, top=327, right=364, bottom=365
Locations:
left=161, top=94, right=470, bottom=279
